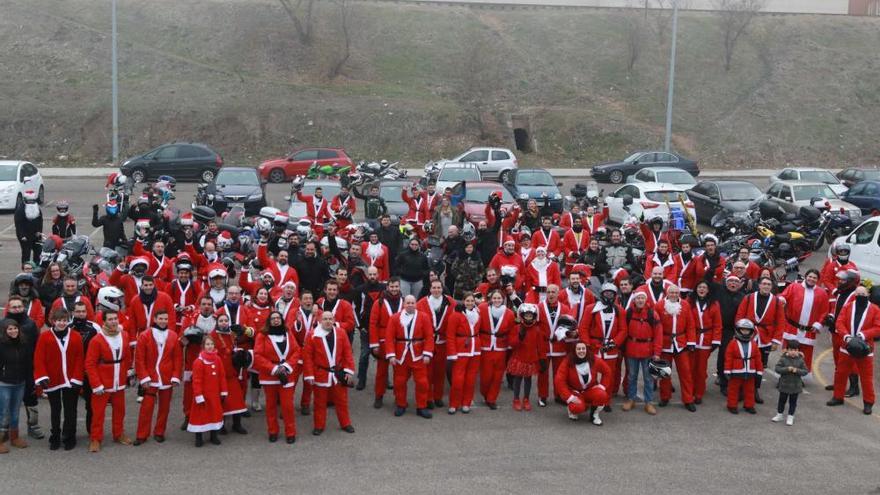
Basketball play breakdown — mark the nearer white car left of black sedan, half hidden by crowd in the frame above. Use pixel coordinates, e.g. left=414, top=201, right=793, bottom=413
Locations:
left=605, top=182, right=698, bottom=224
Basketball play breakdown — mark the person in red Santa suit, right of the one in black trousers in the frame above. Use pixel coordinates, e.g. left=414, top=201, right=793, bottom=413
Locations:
left=85, top=310, right=132, bottom=452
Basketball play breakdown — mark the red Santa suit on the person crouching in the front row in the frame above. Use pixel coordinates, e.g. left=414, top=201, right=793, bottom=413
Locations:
left=553, top=356, right=613, bottom=414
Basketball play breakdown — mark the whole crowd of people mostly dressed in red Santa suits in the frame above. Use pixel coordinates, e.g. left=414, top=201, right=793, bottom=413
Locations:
left=0, top=179, right=880, bottom=453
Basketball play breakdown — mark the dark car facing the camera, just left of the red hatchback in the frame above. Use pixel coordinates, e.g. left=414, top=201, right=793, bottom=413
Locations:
left=206, top=167, right=266, bottom=216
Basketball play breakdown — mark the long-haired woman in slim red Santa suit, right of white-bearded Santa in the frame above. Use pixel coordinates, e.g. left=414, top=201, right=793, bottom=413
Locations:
left=690, top=280, right=720, bottom=404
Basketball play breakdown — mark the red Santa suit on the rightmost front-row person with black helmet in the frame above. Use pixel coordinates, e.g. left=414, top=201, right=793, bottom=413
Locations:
left=834, top=299, right=880, bottom=405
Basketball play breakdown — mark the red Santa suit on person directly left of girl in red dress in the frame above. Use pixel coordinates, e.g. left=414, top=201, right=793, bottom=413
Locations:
left=480, top=303, right=516, bottom=404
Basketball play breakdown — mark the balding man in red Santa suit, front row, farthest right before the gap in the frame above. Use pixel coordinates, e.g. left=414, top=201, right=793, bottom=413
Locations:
left=302, top=312, right=354, bottom=436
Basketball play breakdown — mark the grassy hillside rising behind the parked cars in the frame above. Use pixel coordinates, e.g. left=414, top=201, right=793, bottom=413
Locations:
left=0, top=0, right=880, bottom=166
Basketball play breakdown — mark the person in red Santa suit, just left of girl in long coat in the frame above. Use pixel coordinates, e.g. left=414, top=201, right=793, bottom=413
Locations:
left=134, top=309, right=183, bottom=445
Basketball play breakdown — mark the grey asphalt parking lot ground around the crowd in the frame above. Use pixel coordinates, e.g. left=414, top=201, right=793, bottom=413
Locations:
left=0, top=174, right=880, bottom=494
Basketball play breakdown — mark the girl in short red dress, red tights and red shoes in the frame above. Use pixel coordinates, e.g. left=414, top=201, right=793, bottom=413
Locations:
left=507, top=304, right=547, bottom=411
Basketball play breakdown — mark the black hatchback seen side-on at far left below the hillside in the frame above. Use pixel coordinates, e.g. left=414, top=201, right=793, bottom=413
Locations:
left=119, top=143, right=223, bottom=182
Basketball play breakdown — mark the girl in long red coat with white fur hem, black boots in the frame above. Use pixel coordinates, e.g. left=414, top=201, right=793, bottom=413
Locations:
left=186, top=336, right=228, bottom=447
